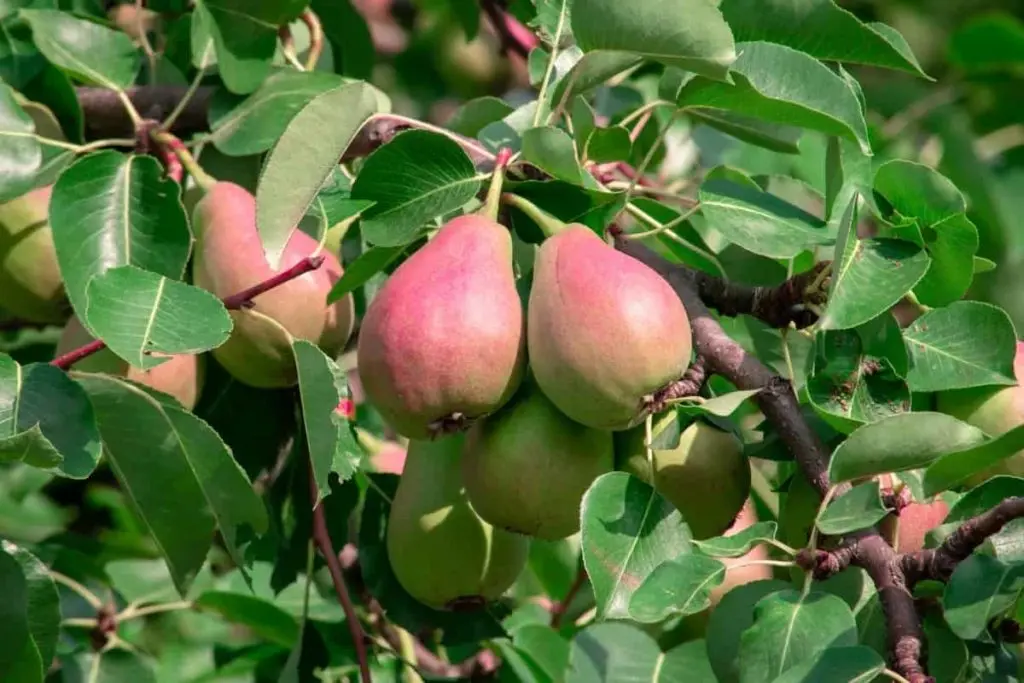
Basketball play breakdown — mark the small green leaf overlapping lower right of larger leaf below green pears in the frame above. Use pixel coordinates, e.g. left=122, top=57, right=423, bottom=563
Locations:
left=629, top=554, right=725, bottom=624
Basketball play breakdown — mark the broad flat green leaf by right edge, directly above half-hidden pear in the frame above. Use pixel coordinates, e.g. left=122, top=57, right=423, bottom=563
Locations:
left=903, top=301, right=1017, bottom=391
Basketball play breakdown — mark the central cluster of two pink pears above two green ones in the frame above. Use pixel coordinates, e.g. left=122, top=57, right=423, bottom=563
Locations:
left=357, top=215, right=700, bottom=609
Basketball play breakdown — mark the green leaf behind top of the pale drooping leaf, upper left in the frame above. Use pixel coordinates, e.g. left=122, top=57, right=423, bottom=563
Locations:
left=208, top=69, right=344, bottom=157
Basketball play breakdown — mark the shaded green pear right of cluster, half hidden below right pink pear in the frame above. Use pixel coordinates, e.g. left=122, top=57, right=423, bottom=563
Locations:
left=615, top=412, right=751, bottom=540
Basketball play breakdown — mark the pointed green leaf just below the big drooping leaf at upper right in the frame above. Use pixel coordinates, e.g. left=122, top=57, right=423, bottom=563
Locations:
left=699, top=178, right=836, bottom=258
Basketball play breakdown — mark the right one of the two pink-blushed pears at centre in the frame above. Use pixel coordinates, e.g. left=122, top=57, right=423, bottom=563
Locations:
left=526, top=224, right=692, bottom=431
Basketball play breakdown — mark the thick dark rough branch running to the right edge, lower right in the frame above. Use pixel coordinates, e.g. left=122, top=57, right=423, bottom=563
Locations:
left=900, top=498, right=1024, bottom=586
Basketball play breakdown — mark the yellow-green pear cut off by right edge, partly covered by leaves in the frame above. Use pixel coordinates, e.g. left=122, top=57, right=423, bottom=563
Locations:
left=936, top=341, right=1024, bottom=487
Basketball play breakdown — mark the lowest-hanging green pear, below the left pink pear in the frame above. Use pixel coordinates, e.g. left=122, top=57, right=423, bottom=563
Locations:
left=386, top=433, right=529, bottom=610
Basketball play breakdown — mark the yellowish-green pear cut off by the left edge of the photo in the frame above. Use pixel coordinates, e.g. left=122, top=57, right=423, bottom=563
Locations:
left=0, top=185, right=71, bottom=324
